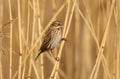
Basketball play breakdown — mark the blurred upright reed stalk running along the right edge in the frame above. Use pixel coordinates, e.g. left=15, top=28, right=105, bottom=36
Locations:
left=114, top=1, right=120, bottom=79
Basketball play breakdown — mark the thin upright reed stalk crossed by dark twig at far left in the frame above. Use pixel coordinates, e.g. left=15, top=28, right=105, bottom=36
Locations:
left=8, top=0, right=13, bottom=79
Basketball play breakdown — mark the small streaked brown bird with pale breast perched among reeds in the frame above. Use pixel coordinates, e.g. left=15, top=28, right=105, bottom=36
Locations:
left=35, top=21, right=63, bottom=60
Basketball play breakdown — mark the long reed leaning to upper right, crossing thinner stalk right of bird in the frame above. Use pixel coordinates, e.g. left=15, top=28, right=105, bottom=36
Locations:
left=90, top=0, right=115, bottom=79
